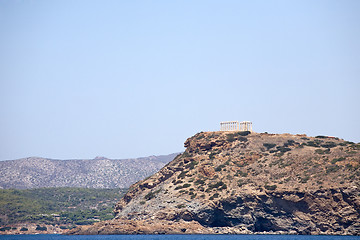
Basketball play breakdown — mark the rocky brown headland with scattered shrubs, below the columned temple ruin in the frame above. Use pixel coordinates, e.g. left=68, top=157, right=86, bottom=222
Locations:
left=70, top=132, right=360, bottom=235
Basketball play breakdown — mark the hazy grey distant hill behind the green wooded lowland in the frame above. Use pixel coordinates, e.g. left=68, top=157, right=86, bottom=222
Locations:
left=0, top=153, right=178, bottom=189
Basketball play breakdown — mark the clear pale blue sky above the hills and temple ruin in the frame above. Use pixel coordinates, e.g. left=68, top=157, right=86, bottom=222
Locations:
left=0, top=0, right=360, bottom=160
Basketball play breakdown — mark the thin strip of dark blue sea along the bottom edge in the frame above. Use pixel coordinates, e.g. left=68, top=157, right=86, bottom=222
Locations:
left=0, top=234, right=360, bottom=240
